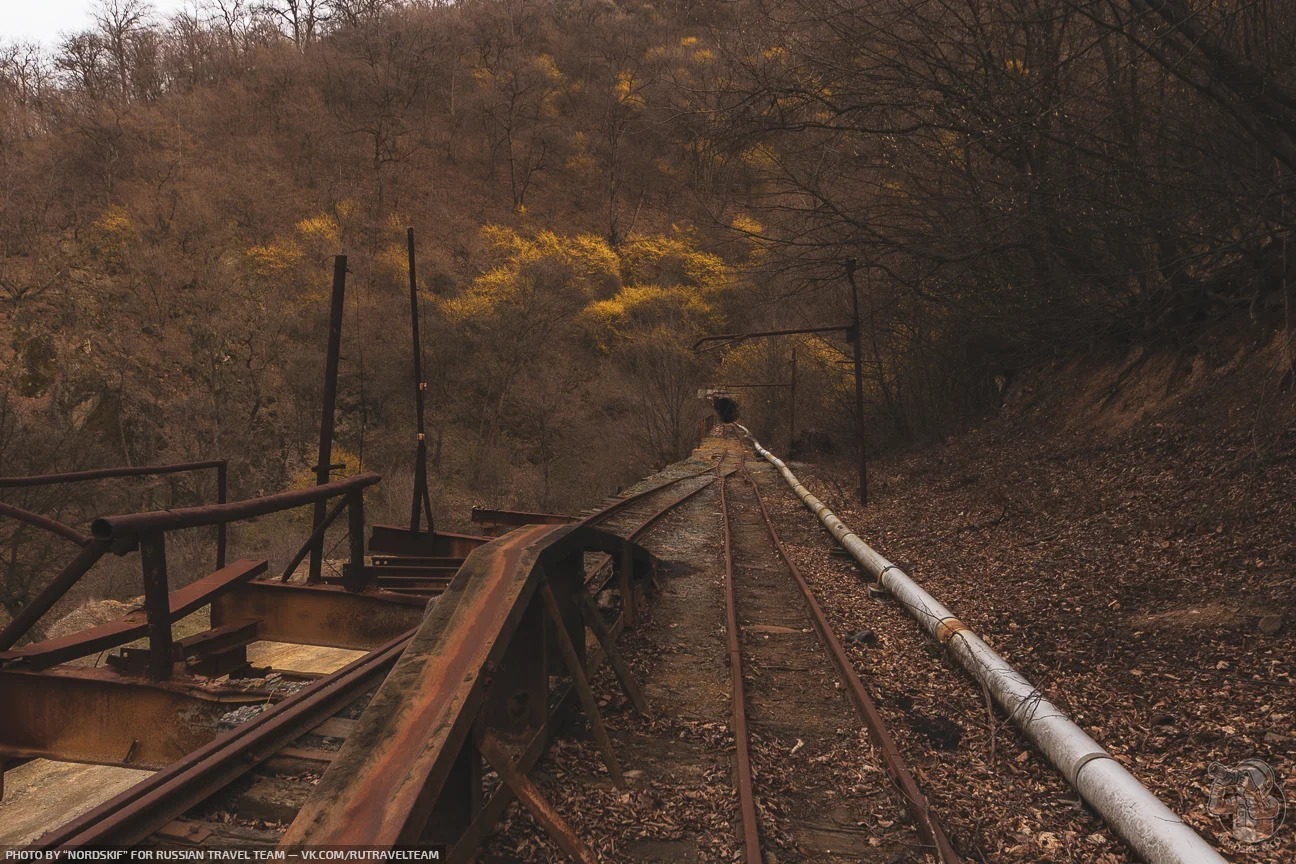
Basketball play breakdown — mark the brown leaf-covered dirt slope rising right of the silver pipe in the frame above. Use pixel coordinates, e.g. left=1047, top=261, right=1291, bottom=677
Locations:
left=793, top=329, right=1296, bottom=863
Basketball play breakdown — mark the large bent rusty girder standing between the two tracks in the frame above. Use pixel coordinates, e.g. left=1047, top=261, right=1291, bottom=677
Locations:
left=283, top=525, right=652, bottom=846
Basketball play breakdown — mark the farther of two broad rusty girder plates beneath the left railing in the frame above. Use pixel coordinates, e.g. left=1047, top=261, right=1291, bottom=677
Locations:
left=211, top=580, right=428, bottom=650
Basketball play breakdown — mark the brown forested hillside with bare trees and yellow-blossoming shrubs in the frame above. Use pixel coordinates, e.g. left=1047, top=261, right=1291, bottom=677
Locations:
left=0, top=0, right=1296, bottom=619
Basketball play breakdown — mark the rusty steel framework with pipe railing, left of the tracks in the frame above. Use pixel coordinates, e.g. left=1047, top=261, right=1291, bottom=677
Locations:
left=0, top=464, right=486, bottom=787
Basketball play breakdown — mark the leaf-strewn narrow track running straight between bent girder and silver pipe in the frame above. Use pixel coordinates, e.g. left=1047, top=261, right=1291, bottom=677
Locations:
left=717, top=449, right=960, bottom=864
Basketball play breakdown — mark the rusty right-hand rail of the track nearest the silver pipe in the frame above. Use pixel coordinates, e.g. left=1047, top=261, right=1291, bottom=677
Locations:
left=741, top=459, right=963, bottom=864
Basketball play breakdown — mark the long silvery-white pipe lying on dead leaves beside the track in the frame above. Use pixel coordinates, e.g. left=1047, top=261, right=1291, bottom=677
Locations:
left=735, top=424, right=1225, bottom=864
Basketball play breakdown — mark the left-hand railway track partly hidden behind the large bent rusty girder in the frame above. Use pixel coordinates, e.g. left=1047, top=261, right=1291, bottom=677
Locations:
left=32, top=458, right=714, bottom=856
